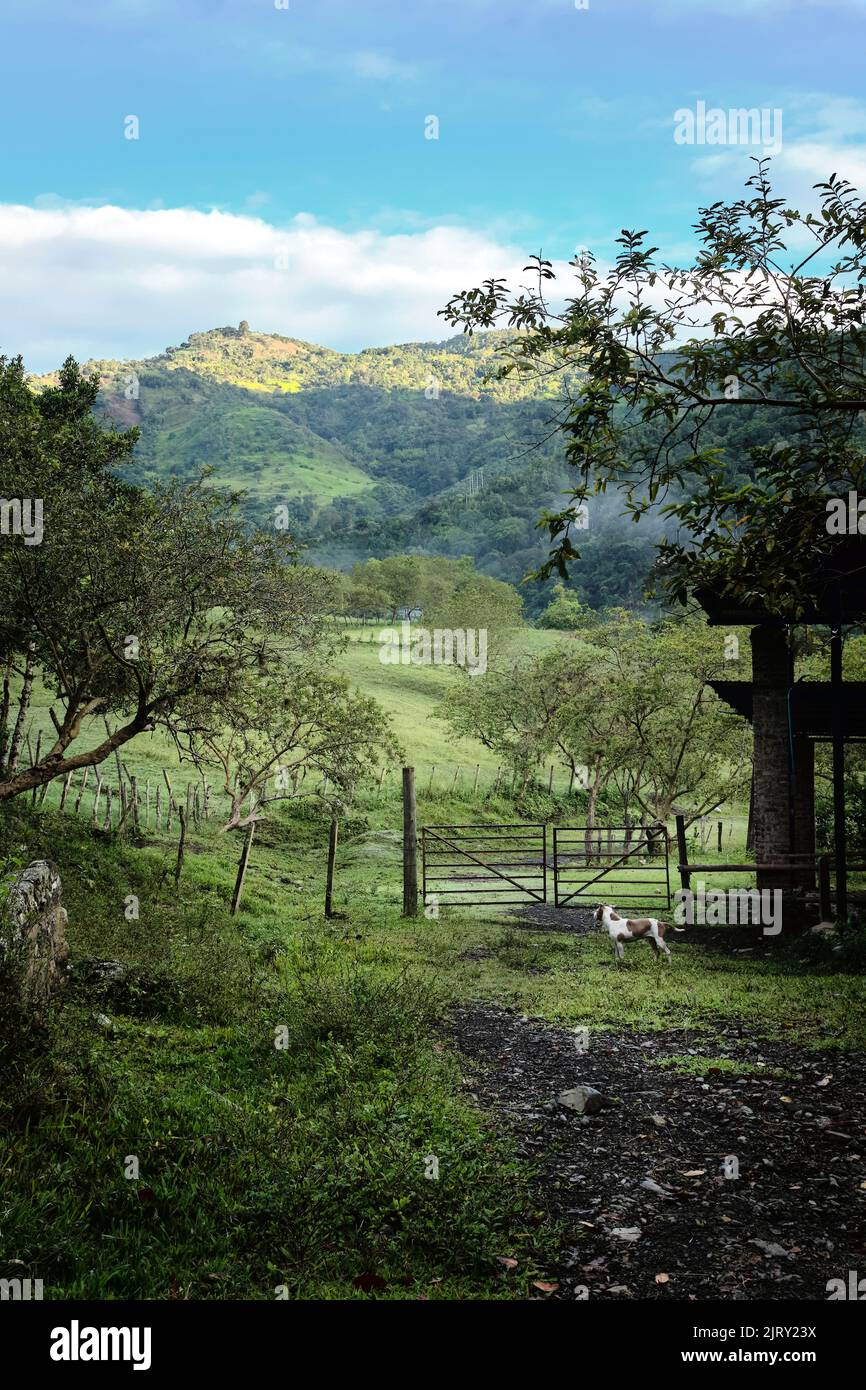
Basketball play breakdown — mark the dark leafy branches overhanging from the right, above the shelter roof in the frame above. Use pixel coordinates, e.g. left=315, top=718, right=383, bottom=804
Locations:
left=441, top=160, right=866, bottom=617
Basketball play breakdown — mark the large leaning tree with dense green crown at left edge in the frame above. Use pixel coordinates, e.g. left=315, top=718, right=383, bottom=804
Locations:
left=0, top=353, right=381, bottom=801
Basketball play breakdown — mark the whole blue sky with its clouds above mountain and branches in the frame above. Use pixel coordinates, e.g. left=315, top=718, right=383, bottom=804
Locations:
left=0, top=0, right=866, bottom=370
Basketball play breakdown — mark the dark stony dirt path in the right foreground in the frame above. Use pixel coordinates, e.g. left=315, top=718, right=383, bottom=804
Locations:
left=453, top=1006, right=866, bottom=1300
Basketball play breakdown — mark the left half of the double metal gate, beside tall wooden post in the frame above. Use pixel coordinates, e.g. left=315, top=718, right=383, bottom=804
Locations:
left=421, top=821, right=548, bottom=908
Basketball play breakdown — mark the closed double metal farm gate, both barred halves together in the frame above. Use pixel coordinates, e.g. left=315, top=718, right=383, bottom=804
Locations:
left=421, top=821, right=670, bottom=912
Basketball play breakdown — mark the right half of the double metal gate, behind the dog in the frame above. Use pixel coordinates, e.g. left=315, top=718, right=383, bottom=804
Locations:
left=553, top=826, right=670, bottom=912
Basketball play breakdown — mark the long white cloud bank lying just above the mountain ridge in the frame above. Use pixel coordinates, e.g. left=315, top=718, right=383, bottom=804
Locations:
left=0, top=197, right=547, bottom=371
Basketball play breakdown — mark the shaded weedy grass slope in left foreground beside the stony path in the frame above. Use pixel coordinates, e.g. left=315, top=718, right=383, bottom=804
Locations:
left=0, top=813, right=556, bottom=1298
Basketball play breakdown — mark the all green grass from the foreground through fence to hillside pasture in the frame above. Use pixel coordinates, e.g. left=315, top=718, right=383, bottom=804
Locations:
left=0, top=628, right=866, bottom=1300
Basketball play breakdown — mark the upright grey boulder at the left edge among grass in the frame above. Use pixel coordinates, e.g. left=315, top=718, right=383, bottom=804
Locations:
left=0, top=859, right=70, bottom=1016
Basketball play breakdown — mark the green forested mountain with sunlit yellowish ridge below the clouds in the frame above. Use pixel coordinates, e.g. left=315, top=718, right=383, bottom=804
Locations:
left=35, top=322, right=800, bottom=617
